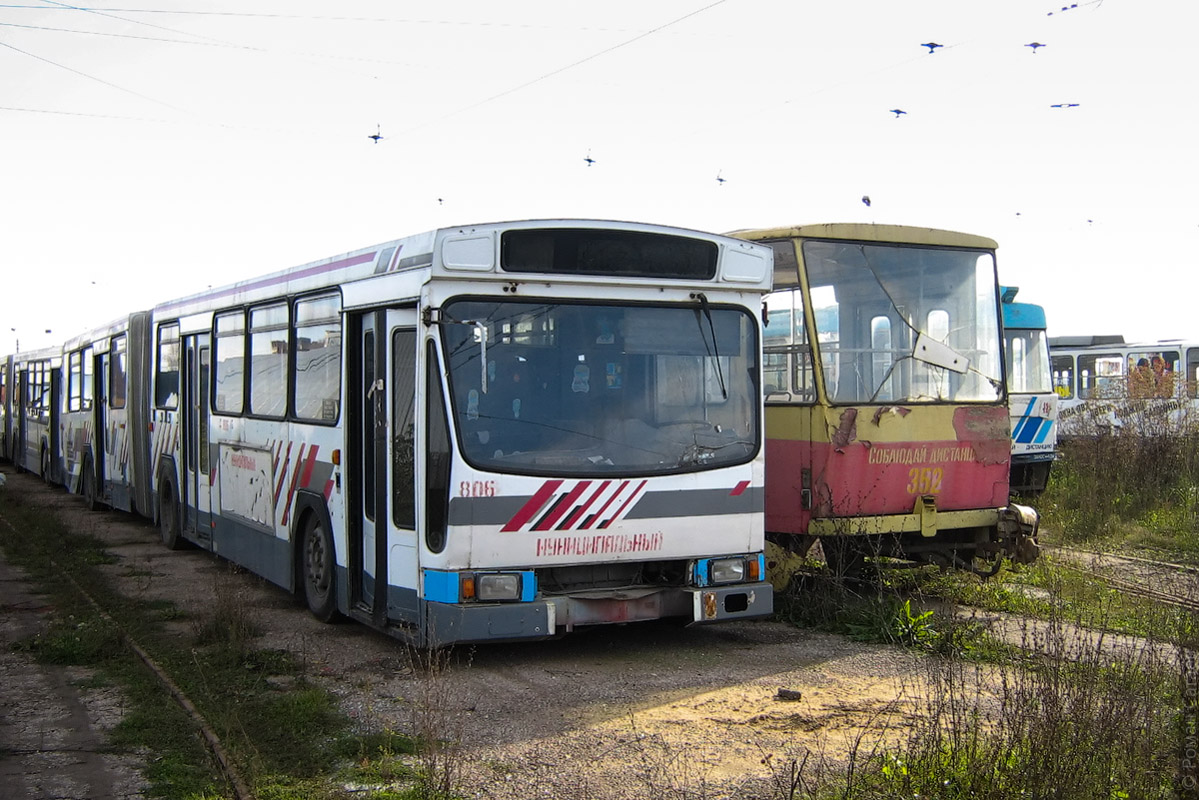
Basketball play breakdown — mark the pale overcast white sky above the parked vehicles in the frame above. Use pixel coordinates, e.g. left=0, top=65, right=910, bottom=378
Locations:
left=0, top=0, right=1199, bottom=353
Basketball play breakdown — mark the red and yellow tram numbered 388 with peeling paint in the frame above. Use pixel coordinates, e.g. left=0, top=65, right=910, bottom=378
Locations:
left=733, top=224, right=1036, bottom=571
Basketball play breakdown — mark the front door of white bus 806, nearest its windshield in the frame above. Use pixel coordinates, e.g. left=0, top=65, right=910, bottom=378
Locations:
left=348, top=309, right=417, bottom=624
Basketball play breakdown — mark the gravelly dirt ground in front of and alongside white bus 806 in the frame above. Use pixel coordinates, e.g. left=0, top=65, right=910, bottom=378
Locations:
left=0, top=476, right=918, bottom=800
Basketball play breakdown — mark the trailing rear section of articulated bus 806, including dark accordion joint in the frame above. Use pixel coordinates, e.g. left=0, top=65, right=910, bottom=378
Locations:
left=59, top=311, right=153, bottom=517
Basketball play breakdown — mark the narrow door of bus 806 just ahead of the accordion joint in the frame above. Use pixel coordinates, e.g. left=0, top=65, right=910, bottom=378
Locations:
left=180, top=335, right=212, bottom=542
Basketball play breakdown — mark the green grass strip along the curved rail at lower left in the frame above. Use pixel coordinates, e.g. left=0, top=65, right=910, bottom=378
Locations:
left=0, top=482, right=427, bottom=800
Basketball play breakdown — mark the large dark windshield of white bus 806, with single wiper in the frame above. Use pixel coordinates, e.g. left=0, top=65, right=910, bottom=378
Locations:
left=441, top=296, right=760, bottom=476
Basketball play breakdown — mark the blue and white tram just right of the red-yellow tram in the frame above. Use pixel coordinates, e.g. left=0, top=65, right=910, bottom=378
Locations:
left=1002, top=287, right=1058, bottom=495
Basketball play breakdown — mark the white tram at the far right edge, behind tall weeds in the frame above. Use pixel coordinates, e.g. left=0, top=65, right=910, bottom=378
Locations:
left=1049, top=335, right=1199, bottom=437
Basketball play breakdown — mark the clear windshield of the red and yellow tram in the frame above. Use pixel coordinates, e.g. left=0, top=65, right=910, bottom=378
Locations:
left=802, top=240, right=1002, bottom=403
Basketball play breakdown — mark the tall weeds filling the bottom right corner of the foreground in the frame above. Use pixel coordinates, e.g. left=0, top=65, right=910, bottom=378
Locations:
left=838, top=609, right=1181, bottom=800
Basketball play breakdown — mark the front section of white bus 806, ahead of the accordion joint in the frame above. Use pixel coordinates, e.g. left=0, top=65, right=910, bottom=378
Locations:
left=140, top=221, right=773, bottom=645
